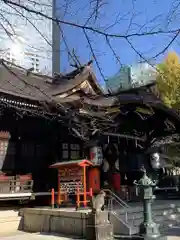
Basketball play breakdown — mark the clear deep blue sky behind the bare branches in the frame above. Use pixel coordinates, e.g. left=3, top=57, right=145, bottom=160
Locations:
left=57, top=0, right=180, bottom=84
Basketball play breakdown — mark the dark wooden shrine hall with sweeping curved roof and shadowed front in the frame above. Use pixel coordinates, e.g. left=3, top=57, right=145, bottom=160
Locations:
left=0, top=58, right=180, bottom=202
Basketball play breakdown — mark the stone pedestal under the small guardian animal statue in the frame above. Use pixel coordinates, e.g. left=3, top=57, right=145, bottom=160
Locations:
left=86, top=211, right=114, bottom=240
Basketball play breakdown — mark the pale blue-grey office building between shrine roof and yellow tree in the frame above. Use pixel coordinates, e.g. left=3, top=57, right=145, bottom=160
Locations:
left=106, top=63, right=156, bottom=93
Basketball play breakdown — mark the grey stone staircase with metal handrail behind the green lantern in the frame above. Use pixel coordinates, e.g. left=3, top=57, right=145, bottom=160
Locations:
left=105, top=190, right=180, bottom=236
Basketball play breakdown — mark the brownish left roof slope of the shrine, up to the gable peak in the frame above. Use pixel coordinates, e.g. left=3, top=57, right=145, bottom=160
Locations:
left=0, top=61, right=102, bottom=102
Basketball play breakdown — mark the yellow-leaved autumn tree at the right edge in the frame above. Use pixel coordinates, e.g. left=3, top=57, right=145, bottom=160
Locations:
left=157, top=52, right=180, bottom=109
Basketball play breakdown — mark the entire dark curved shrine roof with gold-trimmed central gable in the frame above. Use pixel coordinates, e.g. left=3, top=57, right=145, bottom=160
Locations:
left=0, top=61, right=180, bottom=143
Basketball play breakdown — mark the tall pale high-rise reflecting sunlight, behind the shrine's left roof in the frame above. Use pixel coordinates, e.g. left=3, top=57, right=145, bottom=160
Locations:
left=0, top=0, right=60, bottom=75
